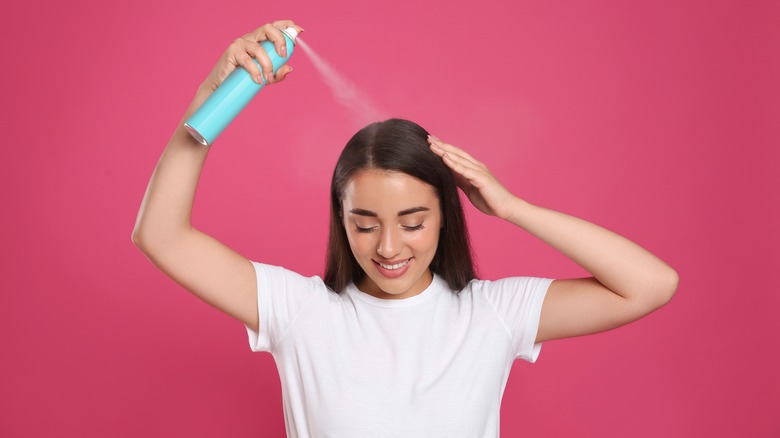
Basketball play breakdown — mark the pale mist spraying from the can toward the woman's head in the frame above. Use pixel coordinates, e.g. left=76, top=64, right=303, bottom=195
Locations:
left=296, top=38, right=387, bottom=127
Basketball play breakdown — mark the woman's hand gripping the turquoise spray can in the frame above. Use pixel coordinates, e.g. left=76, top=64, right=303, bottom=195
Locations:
left=201, top=20, right=303, bottom=94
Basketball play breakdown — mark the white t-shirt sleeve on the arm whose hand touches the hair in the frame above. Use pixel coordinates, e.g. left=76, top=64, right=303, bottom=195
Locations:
left=482, top=277, right=553, bottom=363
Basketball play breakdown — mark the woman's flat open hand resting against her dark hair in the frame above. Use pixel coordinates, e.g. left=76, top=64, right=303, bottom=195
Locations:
left=428, top=135, right=517, bottom=219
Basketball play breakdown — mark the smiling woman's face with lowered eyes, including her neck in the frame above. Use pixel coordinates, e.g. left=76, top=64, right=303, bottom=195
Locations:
left=342, top=169, right=441, bottom=299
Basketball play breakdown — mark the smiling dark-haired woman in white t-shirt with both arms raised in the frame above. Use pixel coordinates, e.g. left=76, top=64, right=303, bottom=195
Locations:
left=133, top=21, right=678, bottom=437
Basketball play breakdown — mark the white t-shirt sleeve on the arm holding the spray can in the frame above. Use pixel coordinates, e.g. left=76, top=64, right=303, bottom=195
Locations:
left=246, top=262, right=327, bottom=351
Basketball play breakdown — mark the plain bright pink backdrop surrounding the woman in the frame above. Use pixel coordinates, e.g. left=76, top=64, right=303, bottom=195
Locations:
left=0, top=0, right=780, bottom=437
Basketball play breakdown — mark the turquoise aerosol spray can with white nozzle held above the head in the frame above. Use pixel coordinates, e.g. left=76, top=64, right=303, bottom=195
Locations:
left=184, top=27, right=298, bottom=146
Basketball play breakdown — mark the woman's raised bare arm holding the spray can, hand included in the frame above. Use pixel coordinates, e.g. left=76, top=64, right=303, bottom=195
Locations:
left=132, top=20, right=303, bottom=331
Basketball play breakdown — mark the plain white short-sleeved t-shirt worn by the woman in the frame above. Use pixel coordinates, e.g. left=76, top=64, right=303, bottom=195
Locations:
left=247, top=263, right=552, bottom=438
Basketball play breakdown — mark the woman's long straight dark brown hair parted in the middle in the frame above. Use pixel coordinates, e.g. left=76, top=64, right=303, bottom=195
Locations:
left=325, top=119, right=476, bottom=292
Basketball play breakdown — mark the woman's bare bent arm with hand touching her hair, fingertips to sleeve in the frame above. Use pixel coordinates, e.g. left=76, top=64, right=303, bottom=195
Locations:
left=429, top=136, right=678, bottom=342
